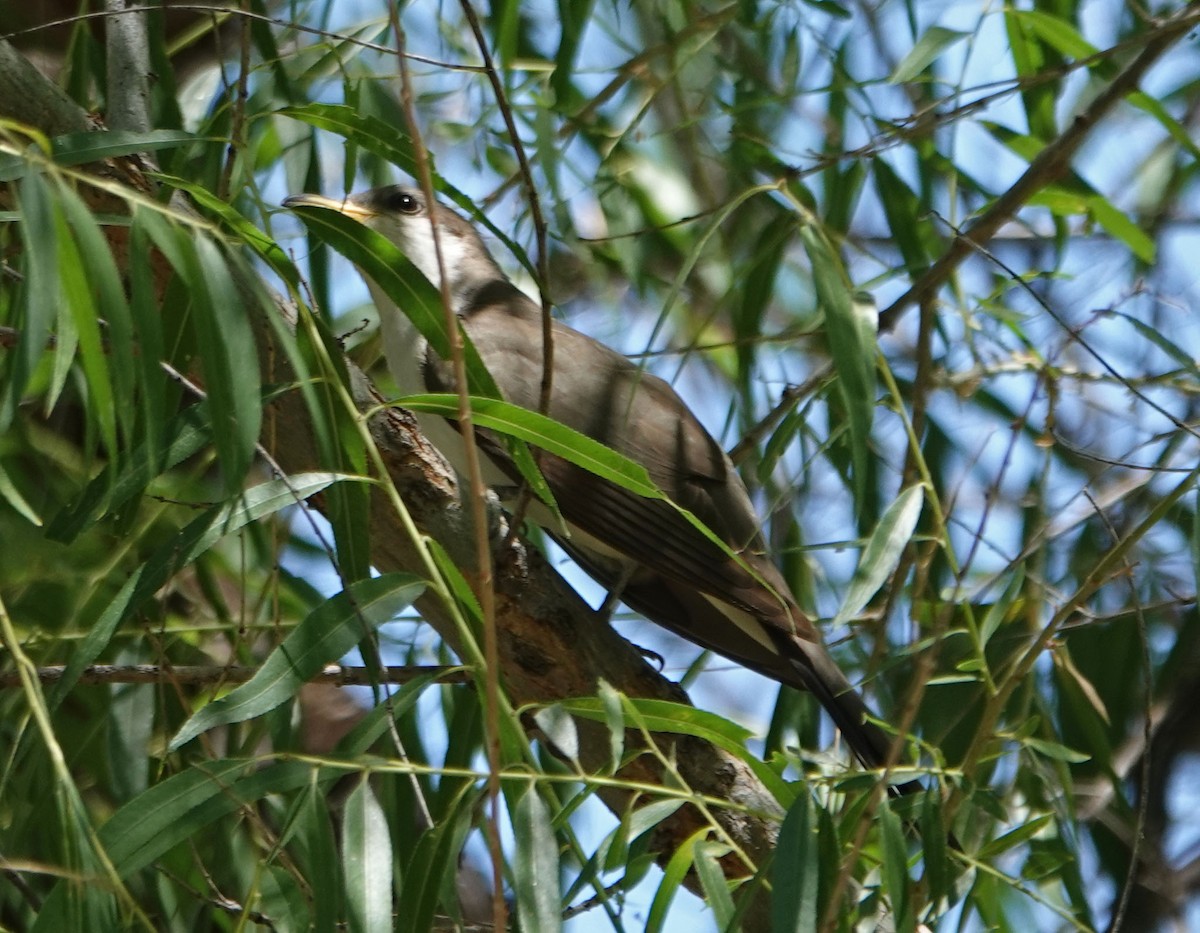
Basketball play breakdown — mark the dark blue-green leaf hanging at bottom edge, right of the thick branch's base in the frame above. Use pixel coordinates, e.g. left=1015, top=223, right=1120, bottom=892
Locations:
left=770, top=790, right=821, bottom=933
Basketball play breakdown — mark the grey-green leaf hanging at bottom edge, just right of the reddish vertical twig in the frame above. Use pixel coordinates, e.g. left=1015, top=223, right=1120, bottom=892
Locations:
left=512, top=787, right=563, bottom=932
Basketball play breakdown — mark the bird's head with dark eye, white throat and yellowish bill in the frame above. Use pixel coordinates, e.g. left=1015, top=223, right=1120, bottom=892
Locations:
left=283, top=185, right=504, bottom=306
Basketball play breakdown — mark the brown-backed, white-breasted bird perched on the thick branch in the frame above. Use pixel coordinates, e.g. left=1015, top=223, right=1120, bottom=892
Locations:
left=283, top=186, right=916, bottom=777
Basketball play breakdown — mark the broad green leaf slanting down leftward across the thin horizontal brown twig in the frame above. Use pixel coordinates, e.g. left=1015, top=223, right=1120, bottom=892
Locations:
left=168, top=573, right=425, bottom=751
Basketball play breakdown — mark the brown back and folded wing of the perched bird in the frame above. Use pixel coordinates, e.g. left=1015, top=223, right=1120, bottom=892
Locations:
left=426, top=285, right=816, bottom=638
